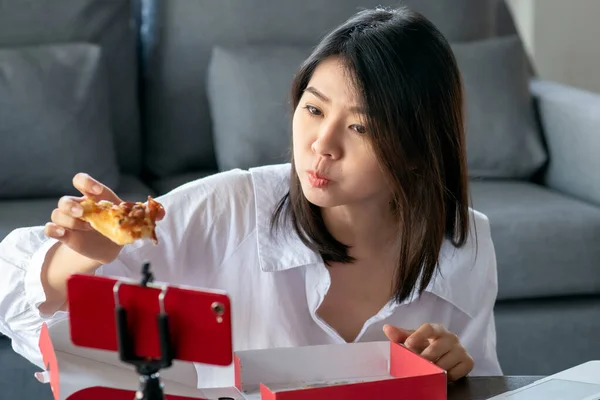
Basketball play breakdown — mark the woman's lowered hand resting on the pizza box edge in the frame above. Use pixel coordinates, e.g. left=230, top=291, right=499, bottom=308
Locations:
left=383, top=324, right=474, bottom=381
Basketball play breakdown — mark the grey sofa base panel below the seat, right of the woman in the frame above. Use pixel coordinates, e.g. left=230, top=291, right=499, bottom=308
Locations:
left=494, top=296, right=600, bottom=376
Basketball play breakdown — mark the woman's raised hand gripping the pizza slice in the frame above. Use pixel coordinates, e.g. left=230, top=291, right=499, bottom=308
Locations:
left=44, top=173, right=122, bottom=264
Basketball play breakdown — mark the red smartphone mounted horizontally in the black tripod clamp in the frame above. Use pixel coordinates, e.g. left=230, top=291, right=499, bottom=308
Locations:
left=67, top=275, right=233, bottom=366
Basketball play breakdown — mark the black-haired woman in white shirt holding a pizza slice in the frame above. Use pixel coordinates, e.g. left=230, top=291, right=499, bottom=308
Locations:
left=0, top=5, right=501, bottom=387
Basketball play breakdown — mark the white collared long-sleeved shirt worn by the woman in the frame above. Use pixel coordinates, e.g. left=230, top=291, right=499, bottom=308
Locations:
left=0, top=164, right=502, bottom=388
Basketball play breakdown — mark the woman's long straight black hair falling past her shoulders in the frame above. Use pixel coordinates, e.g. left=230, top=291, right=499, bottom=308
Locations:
left=271, top=8, right=469, bottom=302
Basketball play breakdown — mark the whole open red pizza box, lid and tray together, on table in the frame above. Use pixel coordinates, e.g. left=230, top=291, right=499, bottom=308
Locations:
left=40, top=321, right=447, bottom=400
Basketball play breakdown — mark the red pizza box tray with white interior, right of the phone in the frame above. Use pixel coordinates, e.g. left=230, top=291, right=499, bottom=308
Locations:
left=234, top=341, right=447, bottom=400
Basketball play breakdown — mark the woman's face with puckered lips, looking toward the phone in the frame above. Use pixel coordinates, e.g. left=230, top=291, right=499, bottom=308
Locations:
left=293, top=58, right=390, bottom=211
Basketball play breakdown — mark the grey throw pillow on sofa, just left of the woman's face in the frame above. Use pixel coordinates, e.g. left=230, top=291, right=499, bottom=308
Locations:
left=207, top=46, right=311, bottom=170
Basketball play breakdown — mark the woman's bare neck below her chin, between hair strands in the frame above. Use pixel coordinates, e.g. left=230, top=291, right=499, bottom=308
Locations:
left=321, top=205, right=398, bottom=261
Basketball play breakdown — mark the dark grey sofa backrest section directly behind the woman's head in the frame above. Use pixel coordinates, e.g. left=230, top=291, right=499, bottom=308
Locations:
left=143, top=0, right=497, bottom=178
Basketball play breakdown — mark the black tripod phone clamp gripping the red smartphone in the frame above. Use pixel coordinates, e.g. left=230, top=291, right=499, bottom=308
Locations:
left=113, top=263, right=175, bottom=400
